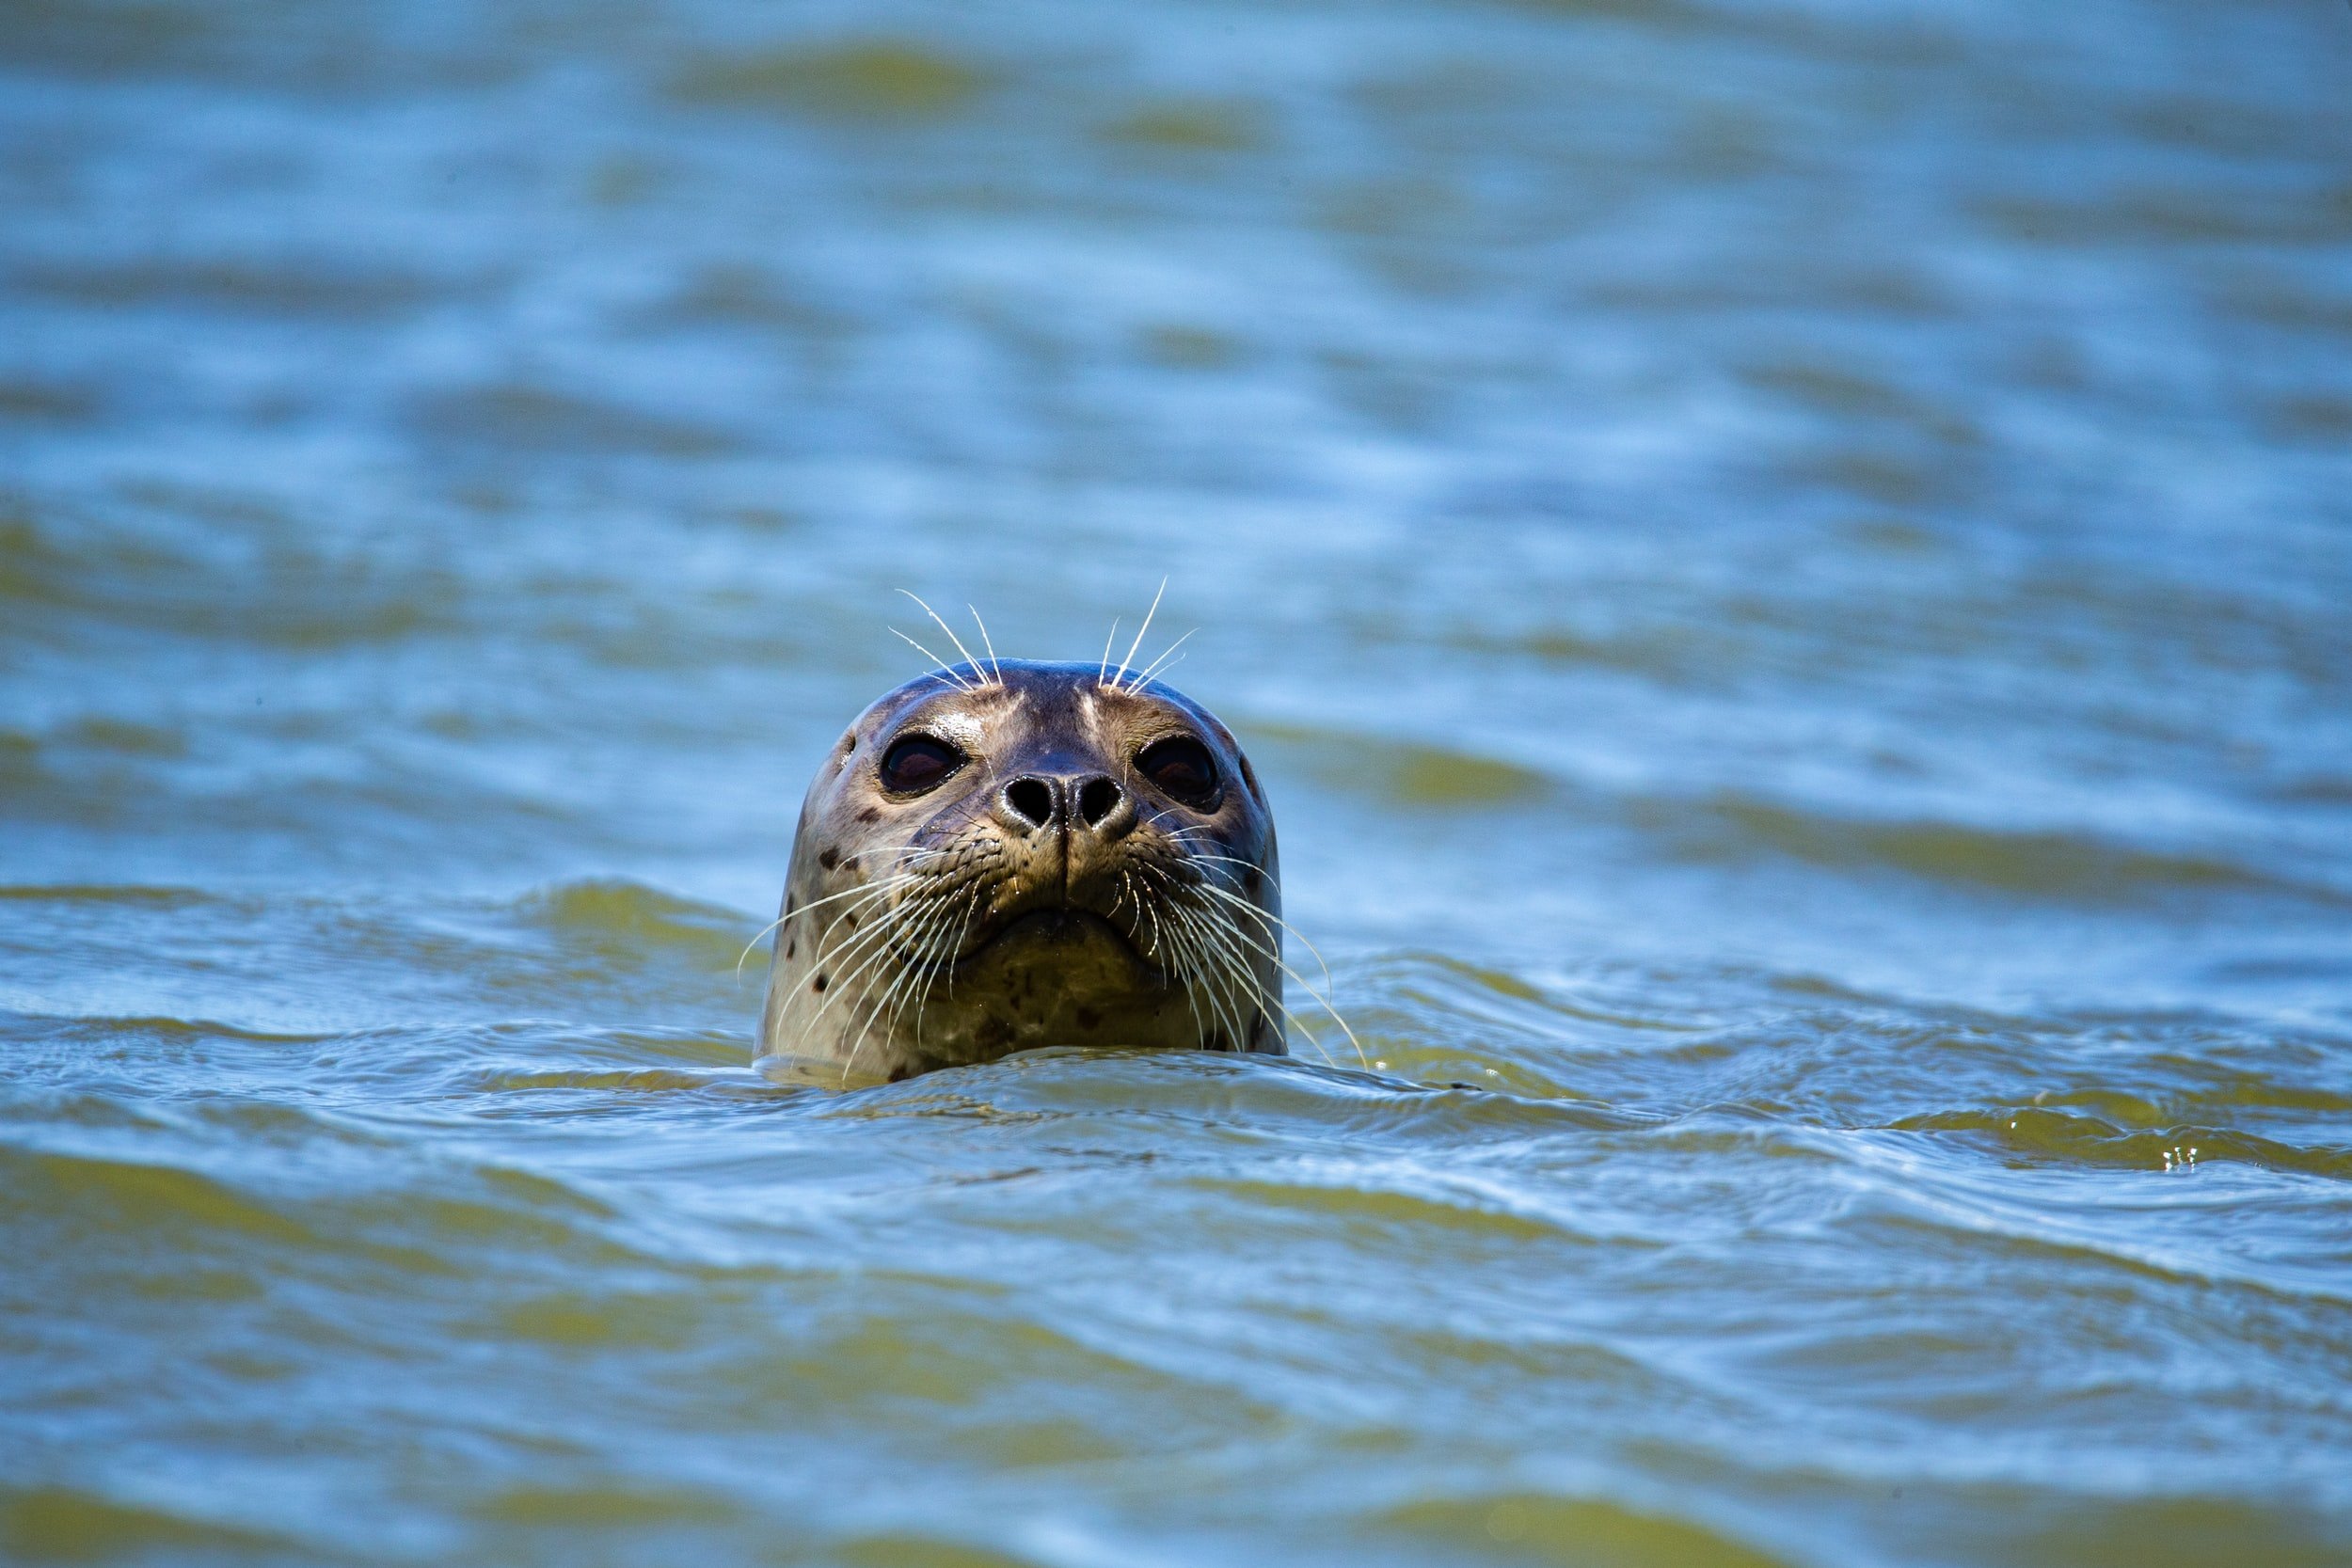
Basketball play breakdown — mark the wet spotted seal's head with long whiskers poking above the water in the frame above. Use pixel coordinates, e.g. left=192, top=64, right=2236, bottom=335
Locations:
left=760, top=660, right=1284, bottom=1079
